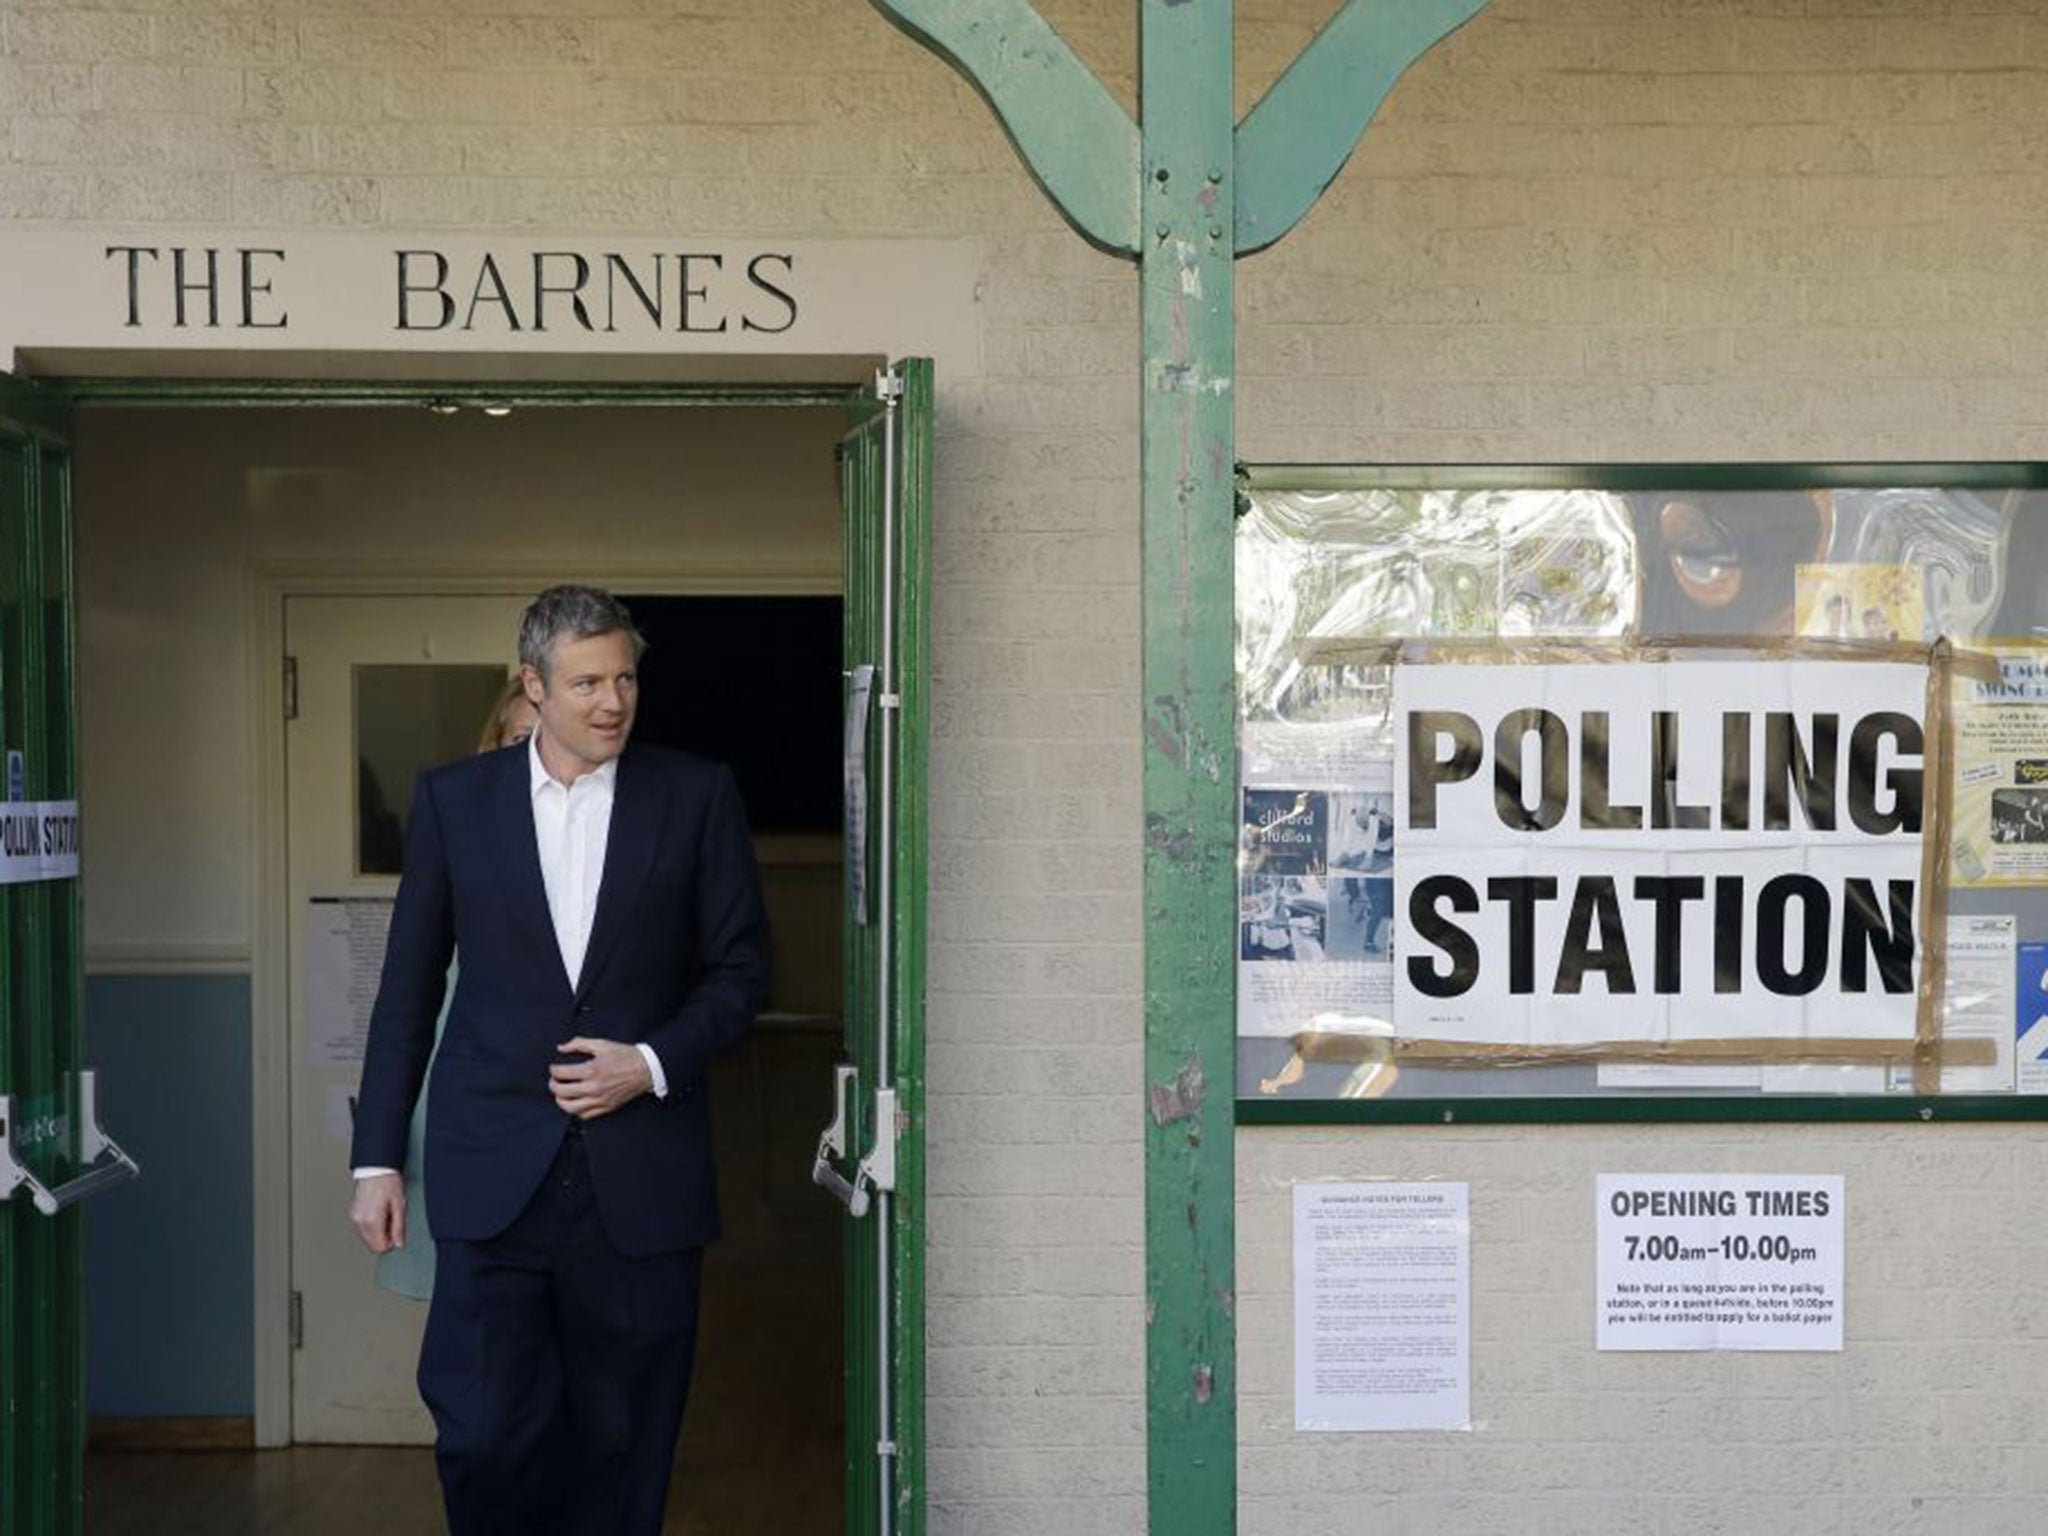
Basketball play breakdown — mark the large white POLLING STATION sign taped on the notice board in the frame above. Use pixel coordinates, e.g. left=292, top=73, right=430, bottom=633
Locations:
left=1393, top=657, right=1927, bottom=1047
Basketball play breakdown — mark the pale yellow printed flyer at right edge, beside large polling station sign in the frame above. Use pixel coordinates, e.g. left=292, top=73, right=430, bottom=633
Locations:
left=1950, top=641, right=2048, bottom=887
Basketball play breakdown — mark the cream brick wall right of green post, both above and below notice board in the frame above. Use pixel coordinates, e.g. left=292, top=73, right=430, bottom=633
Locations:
left=1237, top=0, right=2048, bottom=1536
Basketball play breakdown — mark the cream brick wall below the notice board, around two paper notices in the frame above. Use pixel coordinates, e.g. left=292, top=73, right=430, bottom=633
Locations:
left=1237, top=1126, right=2048, bottom=1536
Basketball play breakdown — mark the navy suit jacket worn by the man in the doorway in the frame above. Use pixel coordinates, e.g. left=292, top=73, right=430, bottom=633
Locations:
left=350, top=745, right=768, bottom=1255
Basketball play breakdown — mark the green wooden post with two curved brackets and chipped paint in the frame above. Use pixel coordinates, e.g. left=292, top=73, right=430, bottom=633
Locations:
left=874, top=0, right=1485, bottom=1536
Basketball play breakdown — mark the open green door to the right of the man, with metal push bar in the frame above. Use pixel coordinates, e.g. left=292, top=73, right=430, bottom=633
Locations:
left=817, top=358, right=932, bottom=1536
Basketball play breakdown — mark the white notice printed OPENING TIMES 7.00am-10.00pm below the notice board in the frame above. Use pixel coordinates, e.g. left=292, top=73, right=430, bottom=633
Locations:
left=1593, top=1174, right=1843, bottom=1350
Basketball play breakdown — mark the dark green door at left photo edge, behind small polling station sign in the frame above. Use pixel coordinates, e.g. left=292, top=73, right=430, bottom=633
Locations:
left=0, top=375, right=84, bottom=1536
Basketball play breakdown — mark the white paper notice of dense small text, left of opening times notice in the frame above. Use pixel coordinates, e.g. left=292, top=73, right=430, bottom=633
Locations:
left=1294, top=1184, right=1473, bottom=1430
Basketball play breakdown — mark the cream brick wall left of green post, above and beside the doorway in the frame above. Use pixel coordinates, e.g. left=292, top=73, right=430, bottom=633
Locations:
left=0, top=0, right=1143, bottom=1536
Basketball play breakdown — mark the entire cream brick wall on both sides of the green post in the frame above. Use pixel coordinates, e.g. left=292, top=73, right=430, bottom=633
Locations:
left=12, top=0, right=2048, bottom=1536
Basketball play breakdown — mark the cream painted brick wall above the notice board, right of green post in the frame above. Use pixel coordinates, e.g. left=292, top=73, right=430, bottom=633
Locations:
left=1239, top=0, right=2048, bottom=461
